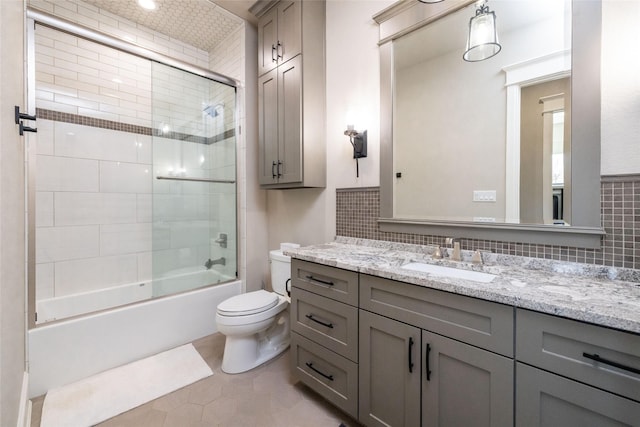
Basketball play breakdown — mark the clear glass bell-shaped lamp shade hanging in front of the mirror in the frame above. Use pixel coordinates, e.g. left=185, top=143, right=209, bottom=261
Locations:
left=462, top=1, right=502, bottom=62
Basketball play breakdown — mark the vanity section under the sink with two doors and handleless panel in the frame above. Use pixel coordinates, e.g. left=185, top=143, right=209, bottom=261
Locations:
left=359, top=275, right=514, bottom=426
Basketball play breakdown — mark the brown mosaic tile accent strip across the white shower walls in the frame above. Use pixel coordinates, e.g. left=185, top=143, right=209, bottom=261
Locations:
left=36, top=108, right=236, bottom=145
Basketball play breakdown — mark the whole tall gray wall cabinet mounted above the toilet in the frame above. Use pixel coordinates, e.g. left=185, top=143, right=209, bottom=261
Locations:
left=252, top=1, right=326, bottom=189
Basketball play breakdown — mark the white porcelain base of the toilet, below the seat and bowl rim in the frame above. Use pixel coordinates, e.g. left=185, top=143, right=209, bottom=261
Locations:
left=222, top=311, right=291, bottom=374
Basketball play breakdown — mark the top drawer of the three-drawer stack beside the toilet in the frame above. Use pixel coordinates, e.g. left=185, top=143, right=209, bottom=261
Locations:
left=291, top=259, right=358, bottom=306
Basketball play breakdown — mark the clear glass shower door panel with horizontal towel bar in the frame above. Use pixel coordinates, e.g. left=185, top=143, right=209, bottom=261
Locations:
left=151, top=62, right=237, bottom=296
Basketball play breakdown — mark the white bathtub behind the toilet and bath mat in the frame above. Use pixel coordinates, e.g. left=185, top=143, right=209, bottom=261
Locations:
left=28, top=271, right=242, bottom=398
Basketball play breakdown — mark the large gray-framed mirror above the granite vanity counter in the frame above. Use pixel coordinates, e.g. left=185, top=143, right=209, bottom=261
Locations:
left=374, top=0, right=603, bottom=247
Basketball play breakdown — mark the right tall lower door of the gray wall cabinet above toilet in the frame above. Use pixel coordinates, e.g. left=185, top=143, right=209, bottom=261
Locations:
left=276, top=55, right=302, bottom=184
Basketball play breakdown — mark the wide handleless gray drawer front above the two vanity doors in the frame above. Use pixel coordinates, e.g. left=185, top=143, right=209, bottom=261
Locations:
left=360, top=275, right=513, bottom=357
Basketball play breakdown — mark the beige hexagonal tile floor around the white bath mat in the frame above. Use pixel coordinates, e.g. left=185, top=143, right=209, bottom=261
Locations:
left=31, top=334, right=359, bottom=427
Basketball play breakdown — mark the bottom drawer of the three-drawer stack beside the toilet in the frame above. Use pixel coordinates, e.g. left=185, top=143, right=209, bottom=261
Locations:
left=291, top=332, right=358, bottom=418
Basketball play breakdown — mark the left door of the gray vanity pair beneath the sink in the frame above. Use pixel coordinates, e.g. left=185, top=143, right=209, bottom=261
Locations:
left=358, top=310, right=420, bottom=427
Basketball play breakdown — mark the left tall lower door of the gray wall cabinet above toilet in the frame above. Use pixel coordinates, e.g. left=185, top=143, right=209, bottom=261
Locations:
left=258, top=69, right=278, bottom=184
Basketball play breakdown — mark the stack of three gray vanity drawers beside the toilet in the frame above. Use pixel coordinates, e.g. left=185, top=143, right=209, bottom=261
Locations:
left=291, top=259, right=358, bottom=418
